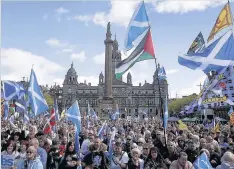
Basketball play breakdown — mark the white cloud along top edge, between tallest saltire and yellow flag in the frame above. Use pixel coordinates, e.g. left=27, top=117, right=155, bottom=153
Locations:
left=152, top=0, right=226, bottom=13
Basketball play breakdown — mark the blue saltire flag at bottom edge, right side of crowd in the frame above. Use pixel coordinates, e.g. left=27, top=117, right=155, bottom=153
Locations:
left=193, top=152, right=213, bottom=169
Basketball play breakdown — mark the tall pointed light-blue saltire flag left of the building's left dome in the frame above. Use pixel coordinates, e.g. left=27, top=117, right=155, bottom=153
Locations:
left=28, top=69, right=49, bottom=116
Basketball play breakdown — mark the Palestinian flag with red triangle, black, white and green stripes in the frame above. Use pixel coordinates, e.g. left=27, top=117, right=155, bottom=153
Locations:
left=115, top=29, right=155, bottom=79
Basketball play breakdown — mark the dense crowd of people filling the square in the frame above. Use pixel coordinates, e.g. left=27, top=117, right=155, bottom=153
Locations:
left=1, top=116, right=234, bottom=169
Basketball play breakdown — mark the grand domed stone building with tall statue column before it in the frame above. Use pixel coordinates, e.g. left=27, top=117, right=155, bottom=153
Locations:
left=59, top=23, right=168, bottom=118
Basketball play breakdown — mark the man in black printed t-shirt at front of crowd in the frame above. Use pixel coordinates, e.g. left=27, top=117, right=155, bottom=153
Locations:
left=83, top=137, right=109, bottom=169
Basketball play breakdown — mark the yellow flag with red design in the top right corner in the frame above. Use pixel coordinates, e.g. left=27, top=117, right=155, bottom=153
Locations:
left=207, top=2, right=233, bottom=42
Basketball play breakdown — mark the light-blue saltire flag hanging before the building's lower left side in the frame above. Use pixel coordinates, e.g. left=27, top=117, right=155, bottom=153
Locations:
left=66, top=100, right=81, bottom=133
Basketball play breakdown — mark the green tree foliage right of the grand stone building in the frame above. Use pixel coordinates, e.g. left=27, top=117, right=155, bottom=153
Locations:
left=168, top=93, right=197, bottom=114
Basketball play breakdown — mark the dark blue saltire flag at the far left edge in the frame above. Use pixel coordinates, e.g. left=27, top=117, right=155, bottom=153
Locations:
left=2, top=80, right=24, bottom=101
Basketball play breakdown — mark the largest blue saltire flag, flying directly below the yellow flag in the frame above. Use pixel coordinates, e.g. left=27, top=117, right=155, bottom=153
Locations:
left=178, top=30, right=234, bottom=73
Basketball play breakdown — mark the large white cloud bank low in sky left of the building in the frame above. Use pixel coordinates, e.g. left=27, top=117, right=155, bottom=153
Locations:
left=1, top=48, right=66, bottom=85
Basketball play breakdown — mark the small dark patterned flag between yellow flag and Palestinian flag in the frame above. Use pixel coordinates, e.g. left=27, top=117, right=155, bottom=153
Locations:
left=187, top=32, right=205, bottom=54
